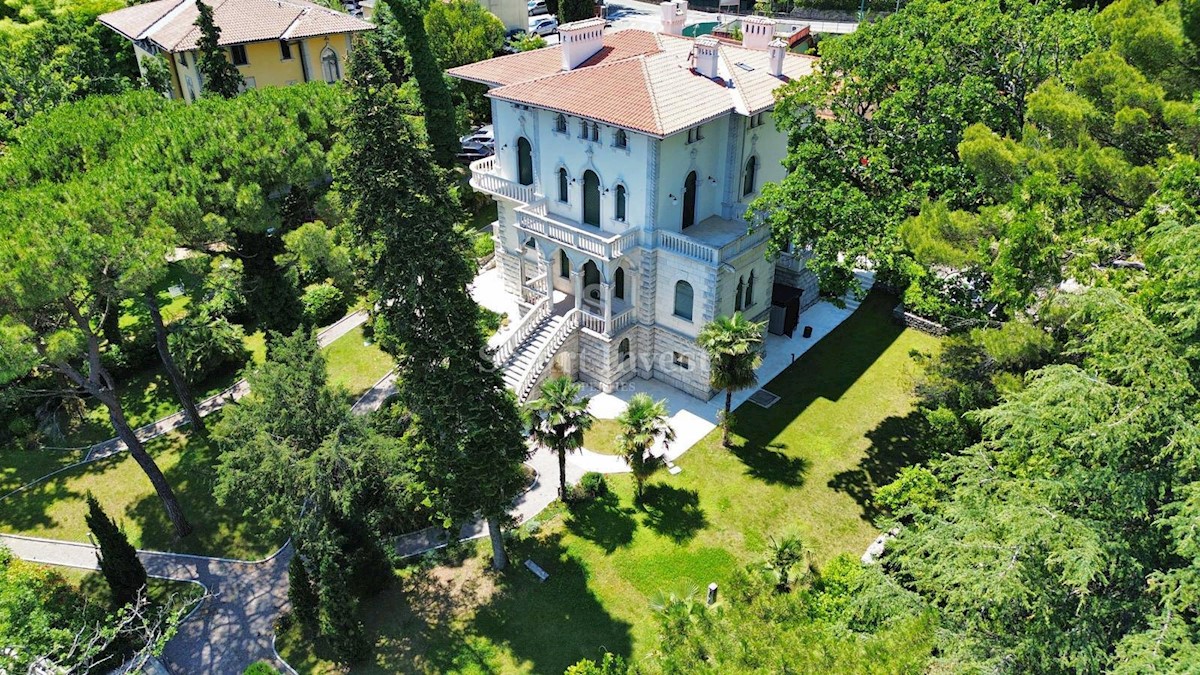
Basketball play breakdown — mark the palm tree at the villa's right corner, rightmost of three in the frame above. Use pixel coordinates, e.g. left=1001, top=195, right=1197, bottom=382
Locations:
left=696, top=312, right=766, bottom=448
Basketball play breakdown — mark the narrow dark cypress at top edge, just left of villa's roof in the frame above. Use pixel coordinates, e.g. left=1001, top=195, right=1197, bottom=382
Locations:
left=388, top=0, right=460, bottom=168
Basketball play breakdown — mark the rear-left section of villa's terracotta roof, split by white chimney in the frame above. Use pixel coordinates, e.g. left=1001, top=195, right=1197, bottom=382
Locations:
left=448, top=30, right=662, bottom=86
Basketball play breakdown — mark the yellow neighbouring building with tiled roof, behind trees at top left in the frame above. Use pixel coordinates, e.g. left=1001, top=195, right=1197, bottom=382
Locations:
left=100, top=0, right=374, bottom=102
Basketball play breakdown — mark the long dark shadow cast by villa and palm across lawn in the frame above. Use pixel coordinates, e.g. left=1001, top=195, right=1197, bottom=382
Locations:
left=732, top=291, right=905, bottom=486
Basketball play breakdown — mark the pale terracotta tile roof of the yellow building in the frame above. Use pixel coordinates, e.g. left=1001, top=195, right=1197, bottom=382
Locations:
left=100, top=0, right=374, bottom=52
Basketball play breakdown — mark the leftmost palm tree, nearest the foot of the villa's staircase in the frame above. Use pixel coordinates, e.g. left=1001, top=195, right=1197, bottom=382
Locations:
left=524, top=377, right=595, bottom=501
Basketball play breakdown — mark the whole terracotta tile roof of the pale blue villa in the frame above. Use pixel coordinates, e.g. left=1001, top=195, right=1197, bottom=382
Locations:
left=463, top=30, right=817, bottom=137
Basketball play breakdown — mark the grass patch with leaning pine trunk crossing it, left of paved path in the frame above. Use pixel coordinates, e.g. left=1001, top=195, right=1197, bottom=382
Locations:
left=0, top=418, right=282, bottom=560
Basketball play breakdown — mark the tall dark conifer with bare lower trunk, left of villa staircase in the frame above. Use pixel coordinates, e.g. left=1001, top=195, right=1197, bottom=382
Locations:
left=338, top=34, right=529, bottom=568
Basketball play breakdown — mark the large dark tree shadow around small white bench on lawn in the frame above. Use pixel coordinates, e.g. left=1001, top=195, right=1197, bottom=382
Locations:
left=468, top=532, right=632, bottom=673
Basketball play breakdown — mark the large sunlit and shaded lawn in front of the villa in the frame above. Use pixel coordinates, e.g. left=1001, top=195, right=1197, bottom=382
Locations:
left=280, top=294, right=937, bottom=674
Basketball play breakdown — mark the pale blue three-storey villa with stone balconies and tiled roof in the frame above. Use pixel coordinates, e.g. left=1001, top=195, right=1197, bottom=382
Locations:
left=450, top=0, right=817, bottom=400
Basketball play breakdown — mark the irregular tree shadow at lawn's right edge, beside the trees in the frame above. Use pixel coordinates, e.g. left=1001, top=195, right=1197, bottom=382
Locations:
left=829, top=403, right=929, bottom=521
